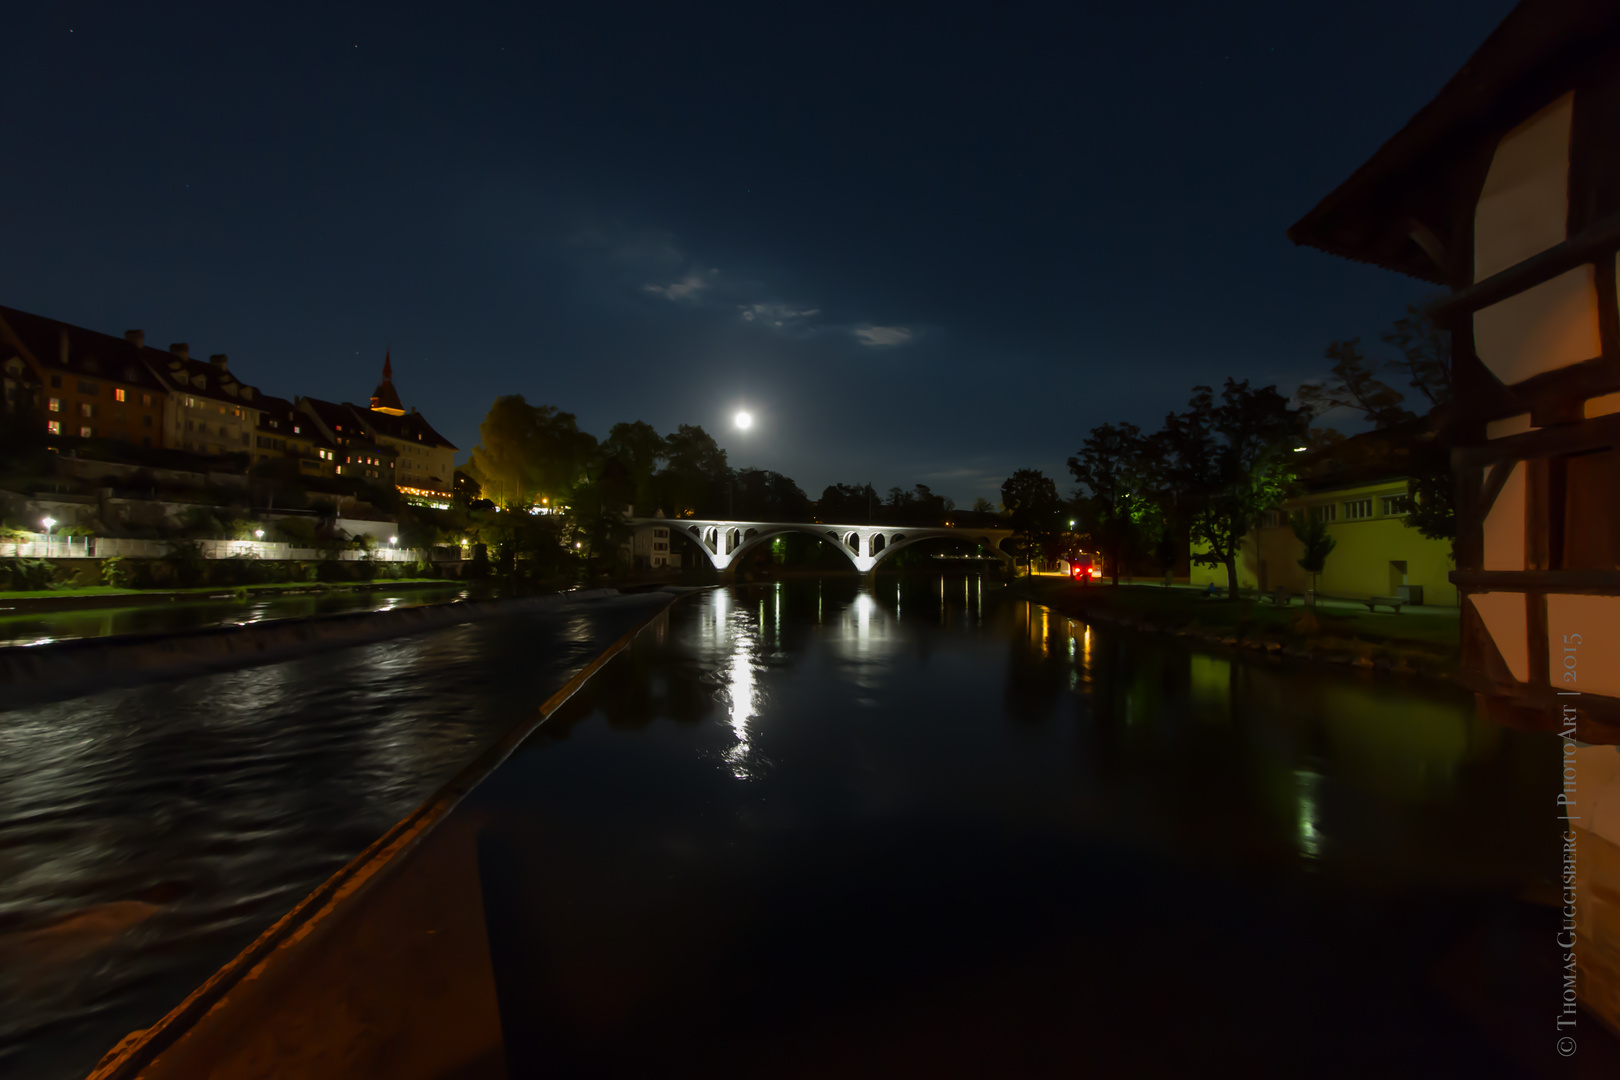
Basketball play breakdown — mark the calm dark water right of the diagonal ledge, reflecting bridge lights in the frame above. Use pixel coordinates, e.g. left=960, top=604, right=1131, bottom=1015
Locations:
left=473, top=576, right=1561, bottom=1078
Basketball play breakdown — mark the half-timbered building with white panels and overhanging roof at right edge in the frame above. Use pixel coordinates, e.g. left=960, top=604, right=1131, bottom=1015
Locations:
left=1290, top=0, right=1620, bottom=1031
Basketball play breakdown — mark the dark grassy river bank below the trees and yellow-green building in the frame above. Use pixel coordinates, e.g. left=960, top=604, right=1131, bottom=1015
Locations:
left=1013, top=578, right=1460, bottom=678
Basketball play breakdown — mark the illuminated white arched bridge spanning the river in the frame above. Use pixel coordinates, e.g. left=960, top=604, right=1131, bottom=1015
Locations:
left=629, top=518, right=1013, bottom=573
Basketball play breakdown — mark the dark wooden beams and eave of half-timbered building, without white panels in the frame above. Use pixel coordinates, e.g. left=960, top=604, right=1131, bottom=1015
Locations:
left=1288, top=0, right=1620, bottom=743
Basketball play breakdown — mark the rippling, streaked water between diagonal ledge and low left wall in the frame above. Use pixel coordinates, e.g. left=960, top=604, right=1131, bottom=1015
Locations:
left=0, top=596, right=664, bottom=1078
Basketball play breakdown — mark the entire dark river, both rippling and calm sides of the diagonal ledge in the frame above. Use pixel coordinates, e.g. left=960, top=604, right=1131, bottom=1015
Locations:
left=0, top=575, right=1560, bottom=1078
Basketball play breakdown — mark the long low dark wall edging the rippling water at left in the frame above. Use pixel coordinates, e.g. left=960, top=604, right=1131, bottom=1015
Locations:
left=0, top=589, right=617, bottom=704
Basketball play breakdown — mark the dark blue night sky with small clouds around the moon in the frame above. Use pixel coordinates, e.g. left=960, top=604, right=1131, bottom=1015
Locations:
left=0, top=0, right=1513, bottom=504
